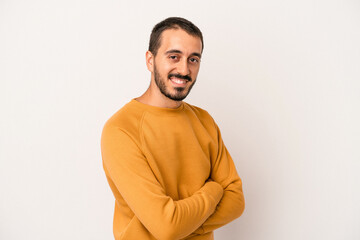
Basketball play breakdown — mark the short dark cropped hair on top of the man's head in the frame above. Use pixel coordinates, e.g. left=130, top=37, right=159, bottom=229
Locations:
left=149, top=17, right=204, bottom=56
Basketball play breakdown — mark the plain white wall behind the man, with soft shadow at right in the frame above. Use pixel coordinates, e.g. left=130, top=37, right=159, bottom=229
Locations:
left=0, top=0, right=360, bottom=240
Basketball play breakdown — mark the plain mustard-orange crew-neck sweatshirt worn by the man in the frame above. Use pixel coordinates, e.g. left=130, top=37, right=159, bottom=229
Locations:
left=101, top=99, right=245, bottom=240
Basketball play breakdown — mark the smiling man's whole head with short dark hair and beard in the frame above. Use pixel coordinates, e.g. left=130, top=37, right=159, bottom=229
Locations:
left=146, top=18, right=204, bottom=101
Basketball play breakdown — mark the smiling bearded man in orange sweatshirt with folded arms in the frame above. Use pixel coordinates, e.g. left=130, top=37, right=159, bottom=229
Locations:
left=101, top=18, right=244, bottom=240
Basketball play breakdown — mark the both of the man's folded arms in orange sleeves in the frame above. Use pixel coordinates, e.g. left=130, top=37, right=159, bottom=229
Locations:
left=102, top=126, right=245, bottom=239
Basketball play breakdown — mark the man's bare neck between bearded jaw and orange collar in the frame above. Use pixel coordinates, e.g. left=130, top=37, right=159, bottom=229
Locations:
left=136, top=81, right=182, bottom=108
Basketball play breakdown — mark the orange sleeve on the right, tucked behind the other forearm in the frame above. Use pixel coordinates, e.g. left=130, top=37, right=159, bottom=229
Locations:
left=194, top=124, right=245, bottom=235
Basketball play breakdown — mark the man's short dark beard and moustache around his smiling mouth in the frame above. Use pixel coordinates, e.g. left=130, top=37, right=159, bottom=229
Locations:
left=154, top=64, right=196, bottom=101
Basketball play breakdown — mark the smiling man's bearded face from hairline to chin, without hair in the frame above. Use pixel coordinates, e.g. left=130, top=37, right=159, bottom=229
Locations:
left=153, top=29, right=202, bottom=101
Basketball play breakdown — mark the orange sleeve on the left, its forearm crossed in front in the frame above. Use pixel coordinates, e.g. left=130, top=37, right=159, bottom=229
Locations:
left=101, top=125, right=224, bottom=239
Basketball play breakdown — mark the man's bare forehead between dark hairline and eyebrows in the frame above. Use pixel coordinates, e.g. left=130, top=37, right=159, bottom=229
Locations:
left=159, top=29, right=202, bottom=54
